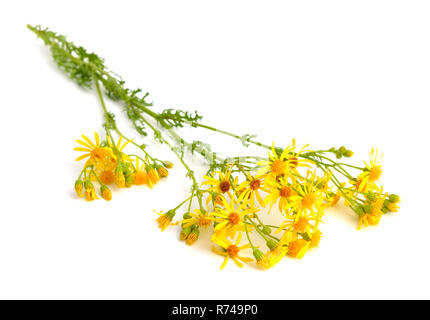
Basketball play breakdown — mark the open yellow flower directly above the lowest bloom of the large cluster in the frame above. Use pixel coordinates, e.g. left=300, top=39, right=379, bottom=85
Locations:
left=210, top=198, right=258, bottom=241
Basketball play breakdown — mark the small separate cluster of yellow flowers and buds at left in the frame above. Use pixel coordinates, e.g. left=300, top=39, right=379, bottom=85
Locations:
left=74, top=132, right=173, bottom=201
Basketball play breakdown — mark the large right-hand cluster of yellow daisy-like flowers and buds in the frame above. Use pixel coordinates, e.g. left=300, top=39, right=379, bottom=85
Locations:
left=157, top=140, right=400, bottom=269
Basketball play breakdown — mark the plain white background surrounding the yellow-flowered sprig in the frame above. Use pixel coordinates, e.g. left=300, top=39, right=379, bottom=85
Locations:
left=0, top=0, right=430, bottom=299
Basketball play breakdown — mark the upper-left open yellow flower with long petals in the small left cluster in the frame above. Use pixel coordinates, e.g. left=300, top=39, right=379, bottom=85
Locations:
left=74, top=132, right=116, bottom=168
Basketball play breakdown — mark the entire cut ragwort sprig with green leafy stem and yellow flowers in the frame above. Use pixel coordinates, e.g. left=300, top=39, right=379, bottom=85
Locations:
left=28, top=25, right=400, bottom=268
